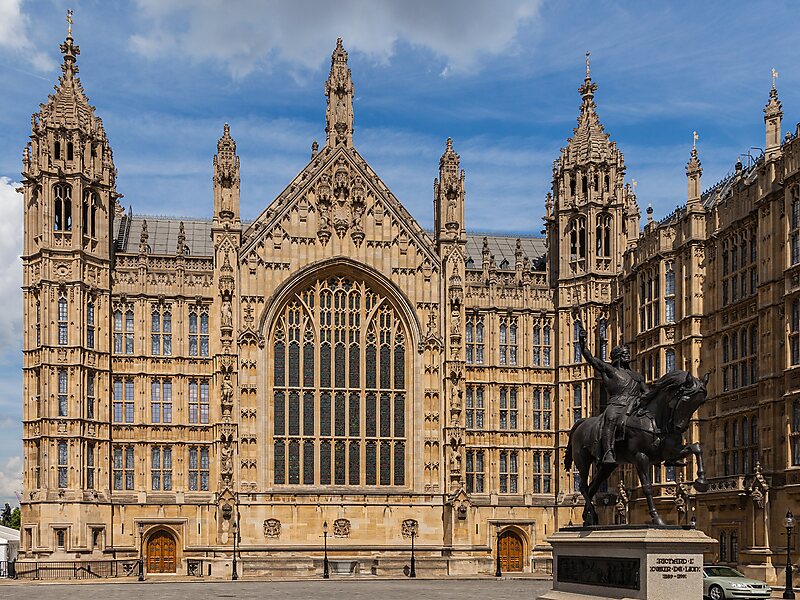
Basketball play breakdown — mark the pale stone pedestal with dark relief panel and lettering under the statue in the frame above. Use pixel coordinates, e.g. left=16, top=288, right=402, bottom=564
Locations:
left=539, top=525, right=715, bottom=600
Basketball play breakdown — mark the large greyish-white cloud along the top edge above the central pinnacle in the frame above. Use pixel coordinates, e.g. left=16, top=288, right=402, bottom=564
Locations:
left=131, top=0, right=541, bottom=76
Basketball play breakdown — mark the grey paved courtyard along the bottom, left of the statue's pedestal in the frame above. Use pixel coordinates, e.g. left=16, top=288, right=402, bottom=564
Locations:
left=0, top=579, right=551, bottom=600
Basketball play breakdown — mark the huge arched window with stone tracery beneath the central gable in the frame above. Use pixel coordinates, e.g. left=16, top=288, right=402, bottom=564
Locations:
left=271, top=277, right=408, bottom=486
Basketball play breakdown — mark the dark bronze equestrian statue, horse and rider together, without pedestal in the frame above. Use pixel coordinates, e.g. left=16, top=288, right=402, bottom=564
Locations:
left=564, top=323, right=708, bottom=525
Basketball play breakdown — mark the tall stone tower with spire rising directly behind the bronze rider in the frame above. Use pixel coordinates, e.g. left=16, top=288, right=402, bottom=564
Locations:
left=545, top=52, right=639, bottom=493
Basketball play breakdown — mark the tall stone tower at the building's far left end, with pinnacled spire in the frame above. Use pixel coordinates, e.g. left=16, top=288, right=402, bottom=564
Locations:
left=22, top=19, right=120, bottom=549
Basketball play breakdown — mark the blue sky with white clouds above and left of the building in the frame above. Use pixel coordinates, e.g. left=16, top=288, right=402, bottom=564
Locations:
left=0, top=0, right=800, bottom=503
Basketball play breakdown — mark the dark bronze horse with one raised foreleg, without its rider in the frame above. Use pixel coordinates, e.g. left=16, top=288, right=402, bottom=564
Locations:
left=564, top=371, right=708, bottom=525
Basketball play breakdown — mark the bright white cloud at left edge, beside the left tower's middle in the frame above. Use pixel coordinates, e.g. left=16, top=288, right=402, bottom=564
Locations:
left=0, top=177, right=22, bottom=351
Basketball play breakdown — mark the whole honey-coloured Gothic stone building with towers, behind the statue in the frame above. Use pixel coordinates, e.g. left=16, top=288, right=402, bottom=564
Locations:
left=15, top=29, right=800, bottom=579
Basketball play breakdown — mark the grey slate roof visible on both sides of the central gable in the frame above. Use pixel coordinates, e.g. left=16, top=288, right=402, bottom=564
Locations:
left=114, top=214, right=545, bottom=270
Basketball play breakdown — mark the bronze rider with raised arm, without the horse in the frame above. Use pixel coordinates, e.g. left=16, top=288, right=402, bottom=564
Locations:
left=578, top=322, right=647, bottom=465
